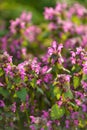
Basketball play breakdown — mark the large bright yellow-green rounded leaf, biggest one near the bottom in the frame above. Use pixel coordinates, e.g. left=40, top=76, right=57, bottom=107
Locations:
left=51, top=104, right=65, bottom=120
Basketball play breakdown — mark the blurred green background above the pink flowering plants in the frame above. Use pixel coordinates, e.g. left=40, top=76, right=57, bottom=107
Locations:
left=0, top=0, right=87, bottom=36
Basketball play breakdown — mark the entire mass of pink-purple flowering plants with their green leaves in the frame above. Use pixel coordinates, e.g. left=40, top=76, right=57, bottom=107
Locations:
left=0, top=3, right=87, bottom=130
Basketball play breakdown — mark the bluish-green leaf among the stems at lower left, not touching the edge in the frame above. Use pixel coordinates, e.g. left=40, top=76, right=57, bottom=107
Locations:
left=16, top=88, right=27, bottom=101
